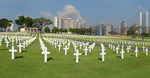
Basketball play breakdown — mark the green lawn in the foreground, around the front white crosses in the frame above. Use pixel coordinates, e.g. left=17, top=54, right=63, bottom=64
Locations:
left=0, top=38, right=150, bottom=78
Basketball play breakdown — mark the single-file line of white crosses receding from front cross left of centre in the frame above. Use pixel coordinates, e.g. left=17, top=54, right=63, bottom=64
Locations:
left=39, top=37, right=50, bottom=62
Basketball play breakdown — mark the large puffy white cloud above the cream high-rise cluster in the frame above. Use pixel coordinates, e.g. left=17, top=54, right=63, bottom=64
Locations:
left=58, top=5, right=86, bottom=22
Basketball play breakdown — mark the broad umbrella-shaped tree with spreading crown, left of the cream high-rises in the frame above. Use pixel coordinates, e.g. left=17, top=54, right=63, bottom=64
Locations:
left=34, top=17, right=52, bottom=33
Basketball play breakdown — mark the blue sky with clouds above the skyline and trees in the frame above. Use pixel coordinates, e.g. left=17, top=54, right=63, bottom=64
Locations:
left=0, top=0, right=150, bottom=26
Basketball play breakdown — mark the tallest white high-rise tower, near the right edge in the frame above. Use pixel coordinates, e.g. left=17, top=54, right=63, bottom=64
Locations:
left=140, top=11, right=148, bottom=33
